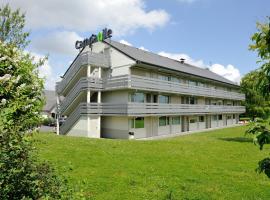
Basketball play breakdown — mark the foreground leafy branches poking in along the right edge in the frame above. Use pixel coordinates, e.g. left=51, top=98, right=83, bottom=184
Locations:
left=247, top=17, right=270, bottom=178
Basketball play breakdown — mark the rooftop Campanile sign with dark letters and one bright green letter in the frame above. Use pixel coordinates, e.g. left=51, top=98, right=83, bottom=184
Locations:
left=75, top=28, right=112, bottom=49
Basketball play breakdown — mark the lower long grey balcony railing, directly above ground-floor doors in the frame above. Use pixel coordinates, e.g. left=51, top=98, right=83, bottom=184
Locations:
left=67, top=103, right=245, bottom=116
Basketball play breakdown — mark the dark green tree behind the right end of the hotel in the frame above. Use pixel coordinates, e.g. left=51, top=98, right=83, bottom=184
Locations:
left=240, top=70, right=270, bottom=120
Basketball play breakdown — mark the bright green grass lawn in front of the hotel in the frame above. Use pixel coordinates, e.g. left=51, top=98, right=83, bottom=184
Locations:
left=35, top=127, right=270, bottom=200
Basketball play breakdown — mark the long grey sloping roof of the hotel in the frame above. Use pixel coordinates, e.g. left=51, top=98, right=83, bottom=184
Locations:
left=105, top=39, right=238, bottom=86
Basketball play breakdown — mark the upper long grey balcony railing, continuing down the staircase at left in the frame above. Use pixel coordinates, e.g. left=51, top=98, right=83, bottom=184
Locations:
left=61, top=75, right=245, bottom=109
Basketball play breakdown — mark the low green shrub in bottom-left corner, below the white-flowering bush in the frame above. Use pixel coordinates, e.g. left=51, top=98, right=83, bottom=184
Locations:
left=0, top=132, right=70, bottom=200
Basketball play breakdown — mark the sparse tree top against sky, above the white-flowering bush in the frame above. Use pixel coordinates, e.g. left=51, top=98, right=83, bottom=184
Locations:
left=0, top=4, right=29, bottom=49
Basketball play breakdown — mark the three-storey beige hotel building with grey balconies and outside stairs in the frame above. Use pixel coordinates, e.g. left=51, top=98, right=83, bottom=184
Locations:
left=56, top=39, right=245, bottom=139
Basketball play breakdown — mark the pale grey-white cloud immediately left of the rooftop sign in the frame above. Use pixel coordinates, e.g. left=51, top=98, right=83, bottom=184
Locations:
left=32, top=31, right=83, bottom=56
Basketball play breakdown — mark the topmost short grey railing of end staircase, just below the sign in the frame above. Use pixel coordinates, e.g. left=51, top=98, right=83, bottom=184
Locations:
left=56, top=51, right=109, bottom=94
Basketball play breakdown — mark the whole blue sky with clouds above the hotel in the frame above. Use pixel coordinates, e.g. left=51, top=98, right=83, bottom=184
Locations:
left=4, top=0, right=270, bottom=89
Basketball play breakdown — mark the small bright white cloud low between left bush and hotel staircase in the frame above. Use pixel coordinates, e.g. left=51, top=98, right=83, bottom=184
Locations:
left=30, top=52, right=59, bottom=90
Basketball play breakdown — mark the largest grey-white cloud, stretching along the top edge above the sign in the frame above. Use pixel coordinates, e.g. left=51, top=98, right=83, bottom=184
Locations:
left=4, top=0, right=170, bottom=35
